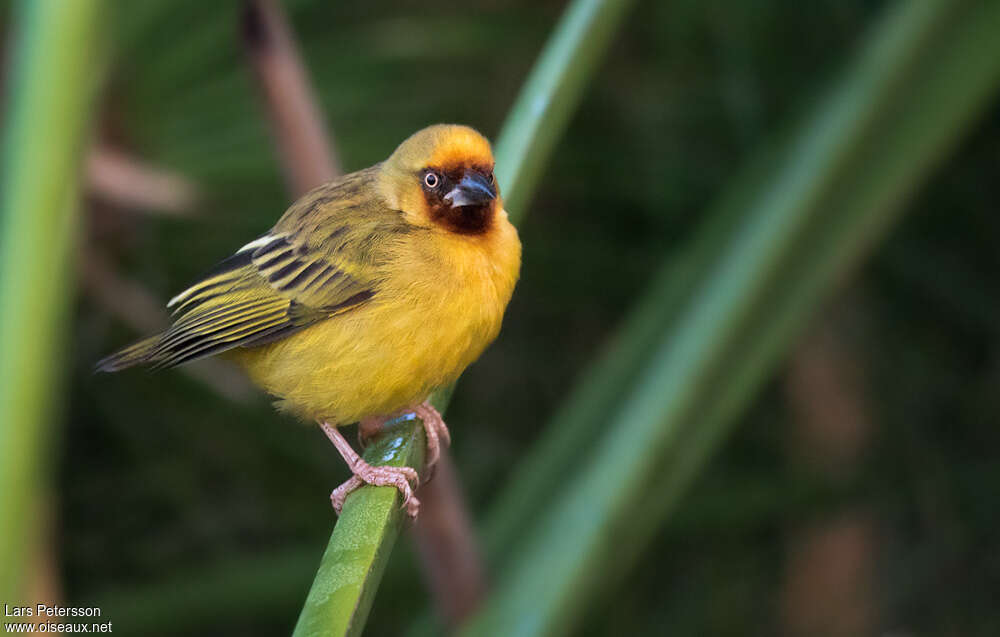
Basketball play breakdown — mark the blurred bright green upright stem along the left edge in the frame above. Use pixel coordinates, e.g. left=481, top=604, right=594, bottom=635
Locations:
left=0, top=0, right=99, bottom=602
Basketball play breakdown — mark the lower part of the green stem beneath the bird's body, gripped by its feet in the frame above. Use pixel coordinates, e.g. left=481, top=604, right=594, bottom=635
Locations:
left=294, top=419, right=426, bottom=637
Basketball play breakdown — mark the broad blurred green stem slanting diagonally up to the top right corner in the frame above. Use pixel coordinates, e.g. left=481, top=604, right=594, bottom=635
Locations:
left=464, top=1, right=1000, bottom=636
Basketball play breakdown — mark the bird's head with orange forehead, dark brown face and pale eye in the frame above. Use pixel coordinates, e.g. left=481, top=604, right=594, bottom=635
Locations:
left=379, top=124, right=502, bottom=235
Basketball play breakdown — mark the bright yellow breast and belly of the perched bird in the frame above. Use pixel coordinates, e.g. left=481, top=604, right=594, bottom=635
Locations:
left=231, top=210, right=521, bottom=424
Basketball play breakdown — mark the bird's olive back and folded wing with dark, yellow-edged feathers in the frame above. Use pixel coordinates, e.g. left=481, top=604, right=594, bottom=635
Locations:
left=146, top=178, right=397, bottom=367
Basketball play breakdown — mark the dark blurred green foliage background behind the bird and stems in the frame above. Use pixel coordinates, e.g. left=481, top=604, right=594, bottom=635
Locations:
left=0, top=0, right=1000, bottom=635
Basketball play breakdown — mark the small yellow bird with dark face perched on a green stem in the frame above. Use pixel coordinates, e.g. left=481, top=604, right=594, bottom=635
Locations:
left=96, top=124, right=521, bottom=517
